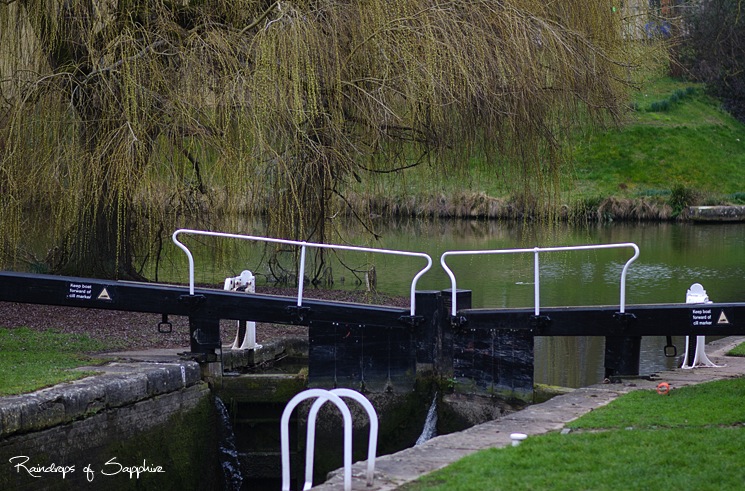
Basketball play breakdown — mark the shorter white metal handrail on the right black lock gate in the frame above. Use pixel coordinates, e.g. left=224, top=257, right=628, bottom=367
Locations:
left=440, top=242, right=639, bottom=317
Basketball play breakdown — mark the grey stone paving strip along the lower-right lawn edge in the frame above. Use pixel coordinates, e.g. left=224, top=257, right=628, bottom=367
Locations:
left=312, top=337, right=745, bottom=491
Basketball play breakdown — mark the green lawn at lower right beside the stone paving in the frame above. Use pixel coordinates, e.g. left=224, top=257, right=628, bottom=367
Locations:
left=402, top=379, right=745, bottom=491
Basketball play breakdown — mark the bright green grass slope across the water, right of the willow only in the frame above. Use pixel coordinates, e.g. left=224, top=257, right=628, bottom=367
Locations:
left=574, top=79, right=745, bottom=201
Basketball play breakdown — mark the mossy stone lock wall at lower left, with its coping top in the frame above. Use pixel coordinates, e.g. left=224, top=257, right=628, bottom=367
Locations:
left=0, top=363, right=223, bottom=491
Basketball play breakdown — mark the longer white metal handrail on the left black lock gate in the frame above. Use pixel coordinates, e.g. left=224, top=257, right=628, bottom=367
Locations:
left=173, top=228, right=432, bottom=316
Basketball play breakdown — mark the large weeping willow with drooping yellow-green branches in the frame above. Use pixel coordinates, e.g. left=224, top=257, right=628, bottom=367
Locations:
left=0, top=0, right=629, bottom=277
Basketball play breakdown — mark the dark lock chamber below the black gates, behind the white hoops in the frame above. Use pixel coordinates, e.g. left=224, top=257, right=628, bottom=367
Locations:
left=206, top=339, right=517, bottom=490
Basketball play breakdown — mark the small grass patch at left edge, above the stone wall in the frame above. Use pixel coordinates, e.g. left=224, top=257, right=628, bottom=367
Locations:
left=0, top=327, right=109, bottom=396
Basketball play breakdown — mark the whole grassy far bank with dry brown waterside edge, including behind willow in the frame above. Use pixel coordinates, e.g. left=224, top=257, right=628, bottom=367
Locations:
left=349, top=76, right=745, bottom=219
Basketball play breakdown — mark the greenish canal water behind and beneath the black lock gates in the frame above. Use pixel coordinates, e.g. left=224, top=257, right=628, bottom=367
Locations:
left=151, top=220, right=745, bottom=387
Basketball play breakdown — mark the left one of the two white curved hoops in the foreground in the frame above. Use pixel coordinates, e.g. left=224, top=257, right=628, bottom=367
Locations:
left=279, top=389, right=352, bottom=491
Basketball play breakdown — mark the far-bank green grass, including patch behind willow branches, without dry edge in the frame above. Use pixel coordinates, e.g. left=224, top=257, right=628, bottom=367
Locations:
left=352, top=76, right=745, bottom=209
